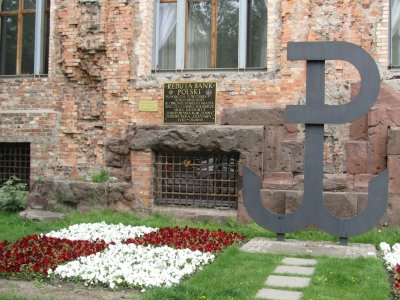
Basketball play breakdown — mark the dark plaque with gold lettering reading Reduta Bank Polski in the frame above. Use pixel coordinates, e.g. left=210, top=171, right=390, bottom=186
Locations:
left=164, top=82, right=217, bottom=124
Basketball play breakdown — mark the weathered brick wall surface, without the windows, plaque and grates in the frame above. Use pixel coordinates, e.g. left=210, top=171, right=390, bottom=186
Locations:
left=0, top=0, right=400, bottom=222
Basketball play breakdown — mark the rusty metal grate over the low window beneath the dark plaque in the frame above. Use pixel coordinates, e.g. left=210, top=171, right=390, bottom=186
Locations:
left=154, top=152, right=239, bottom=208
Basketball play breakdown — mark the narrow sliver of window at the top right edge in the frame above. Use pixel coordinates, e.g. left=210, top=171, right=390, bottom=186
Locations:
left=390, top=0, right=400, bottom=67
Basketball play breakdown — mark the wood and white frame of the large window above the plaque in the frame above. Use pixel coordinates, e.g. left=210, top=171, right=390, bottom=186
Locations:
left=151, top=0, right=267, bottom=72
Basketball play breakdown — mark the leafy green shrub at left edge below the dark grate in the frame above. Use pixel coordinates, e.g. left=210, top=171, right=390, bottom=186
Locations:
left=0, top=176, right=28, bottom=212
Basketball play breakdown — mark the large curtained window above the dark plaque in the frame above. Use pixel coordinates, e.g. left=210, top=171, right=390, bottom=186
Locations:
left=153, top=0, right=267, bottom=70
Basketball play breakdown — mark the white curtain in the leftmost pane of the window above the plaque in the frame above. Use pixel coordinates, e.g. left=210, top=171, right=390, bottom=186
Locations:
left=158, top=3, right=176, bottom=69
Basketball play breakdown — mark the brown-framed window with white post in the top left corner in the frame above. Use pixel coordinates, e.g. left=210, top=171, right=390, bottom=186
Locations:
left=0, top=0, right=50, bottom=75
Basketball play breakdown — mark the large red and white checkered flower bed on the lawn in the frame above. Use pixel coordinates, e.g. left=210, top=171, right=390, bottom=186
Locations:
left=0, top=222, right=244, bottom=288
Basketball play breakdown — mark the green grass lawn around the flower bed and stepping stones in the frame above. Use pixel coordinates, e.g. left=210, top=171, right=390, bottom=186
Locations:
left=0, top=210, right=394, bottom=300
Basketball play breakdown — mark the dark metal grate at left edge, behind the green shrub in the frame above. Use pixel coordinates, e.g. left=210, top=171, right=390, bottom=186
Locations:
left=0, top=143, right=31, bottom=185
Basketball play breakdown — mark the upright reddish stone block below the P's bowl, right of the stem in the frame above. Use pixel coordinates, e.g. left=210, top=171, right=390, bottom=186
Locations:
left=346, top=141, right=368, bottom=174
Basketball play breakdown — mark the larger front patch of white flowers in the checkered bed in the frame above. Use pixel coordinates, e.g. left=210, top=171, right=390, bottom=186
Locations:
left=54, top=243, right=215, bottom=288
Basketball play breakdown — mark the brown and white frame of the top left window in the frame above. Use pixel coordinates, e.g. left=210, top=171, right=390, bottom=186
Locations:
left=0, top=0, right=50, bottom=76
